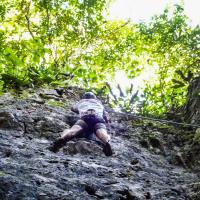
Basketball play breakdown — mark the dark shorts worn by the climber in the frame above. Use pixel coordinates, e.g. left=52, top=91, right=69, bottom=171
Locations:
left=75, top=115, right=106, bottom=132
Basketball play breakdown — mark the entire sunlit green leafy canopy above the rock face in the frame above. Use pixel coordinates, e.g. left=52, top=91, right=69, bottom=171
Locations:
left=0, top=0, right=200, bottom=115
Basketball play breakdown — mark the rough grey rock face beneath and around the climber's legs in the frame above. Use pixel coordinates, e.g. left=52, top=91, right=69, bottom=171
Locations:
left=0, top=91, right=200, bottom=200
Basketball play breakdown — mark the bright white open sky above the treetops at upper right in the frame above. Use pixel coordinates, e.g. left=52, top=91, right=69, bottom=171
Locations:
left=109, top=0, right=200, bottom=25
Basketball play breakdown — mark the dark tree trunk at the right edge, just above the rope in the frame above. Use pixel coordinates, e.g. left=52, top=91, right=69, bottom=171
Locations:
left=183, top=77, right=200, bottom=124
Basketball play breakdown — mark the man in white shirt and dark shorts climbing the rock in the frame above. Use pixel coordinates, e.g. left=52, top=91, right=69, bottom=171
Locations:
left=49, top=92, right=113, bottom=156
